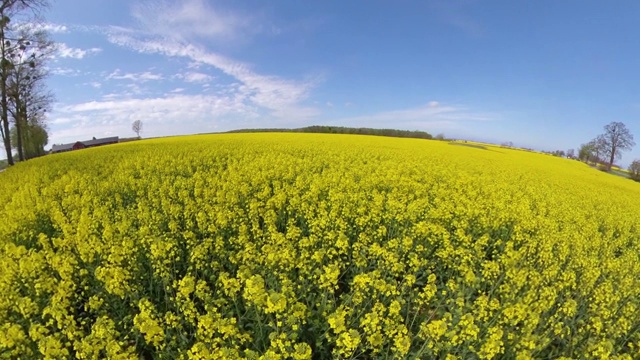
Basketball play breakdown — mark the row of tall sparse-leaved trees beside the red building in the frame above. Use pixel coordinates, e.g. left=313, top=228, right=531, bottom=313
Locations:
left=0, top=0, right=55, bottom=165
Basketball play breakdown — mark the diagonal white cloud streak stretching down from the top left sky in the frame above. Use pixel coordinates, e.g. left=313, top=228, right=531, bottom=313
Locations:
left=97, top=0, right=321, bottom=118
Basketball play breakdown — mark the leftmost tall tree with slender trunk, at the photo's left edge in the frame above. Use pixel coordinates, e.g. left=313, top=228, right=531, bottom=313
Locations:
left=0, top=0, right=48, bottom=165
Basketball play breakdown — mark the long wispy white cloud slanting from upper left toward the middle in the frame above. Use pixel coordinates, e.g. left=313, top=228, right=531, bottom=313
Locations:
left=108, top=0, right=320, bottom=118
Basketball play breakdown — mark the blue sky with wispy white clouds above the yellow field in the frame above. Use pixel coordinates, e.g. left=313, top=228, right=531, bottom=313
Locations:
left=36, top=0, right=640, bottom=164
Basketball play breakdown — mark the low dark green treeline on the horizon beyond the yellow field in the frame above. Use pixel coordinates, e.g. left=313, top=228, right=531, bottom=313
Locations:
left=228, top=125, right=433, bottom=139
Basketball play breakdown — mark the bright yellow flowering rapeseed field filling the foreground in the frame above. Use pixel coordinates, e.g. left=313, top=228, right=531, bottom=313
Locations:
left=0, top=133, right=640, bottom=359
